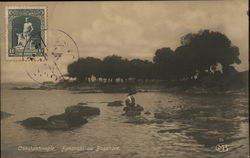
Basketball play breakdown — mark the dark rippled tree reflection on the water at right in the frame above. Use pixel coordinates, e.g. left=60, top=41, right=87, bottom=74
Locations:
left=159, top=96, right=248, bottom=147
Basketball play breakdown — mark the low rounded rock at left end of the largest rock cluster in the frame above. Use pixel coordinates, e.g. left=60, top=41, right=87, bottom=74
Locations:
left=21, top=117, right=48, bottom=128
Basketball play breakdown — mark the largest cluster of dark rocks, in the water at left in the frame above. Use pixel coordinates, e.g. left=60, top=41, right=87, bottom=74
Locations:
left=21, top=104, right=100, bottom=130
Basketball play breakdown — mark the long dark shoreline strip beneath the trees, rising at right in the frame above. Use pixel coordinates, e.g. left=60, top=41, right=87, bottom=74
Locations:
left=2, top=71, right=249, bottom=94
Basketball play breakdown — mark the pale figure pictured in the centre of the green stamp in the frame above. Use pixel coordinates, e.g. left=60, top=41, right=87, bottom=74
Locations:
left=16, top=17, right=34, bottom=49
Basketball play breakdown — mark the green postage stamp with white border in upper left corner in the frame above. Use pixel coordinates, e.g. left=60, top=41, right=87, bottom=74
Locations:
left=6, top=6, right=47, bottom=60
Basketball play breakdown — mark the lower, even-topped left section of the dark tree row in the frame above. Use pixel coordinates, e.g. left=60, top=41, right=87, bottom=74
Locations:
left=68, top=55, right=154, bottom=83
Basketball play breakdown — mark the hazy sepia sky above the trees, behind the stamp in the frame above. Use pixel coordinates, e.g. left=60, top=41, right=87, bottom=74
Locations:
left=0, top=0, right=249, bottom=82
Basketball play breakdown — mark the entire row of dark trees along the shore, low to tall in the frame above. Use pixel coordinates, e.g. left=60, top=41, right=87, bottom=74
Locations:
left=68, top=30, right=241, bottom=82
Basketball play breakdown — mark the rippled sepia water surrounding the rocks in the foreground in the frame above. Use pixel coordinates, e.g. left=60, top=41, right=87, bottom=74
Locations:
left=1, top=89, right=249, bottom=158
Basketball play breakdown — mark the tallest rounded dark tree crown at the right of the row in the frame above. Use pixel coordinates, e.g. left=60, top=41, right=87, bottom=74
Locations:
left=175, top=30, right=241, bottom=77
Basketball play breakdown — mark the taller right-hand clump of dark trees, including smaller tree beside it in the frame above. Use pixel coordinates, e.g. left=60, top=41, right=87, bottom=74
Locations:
left=153, top=30, right=241, bottom=80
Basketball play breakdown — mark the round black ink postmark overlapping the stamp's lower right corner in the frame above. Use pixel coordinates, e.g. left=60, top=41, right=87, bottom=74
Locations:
left=23, top=29, right=79, bottom=84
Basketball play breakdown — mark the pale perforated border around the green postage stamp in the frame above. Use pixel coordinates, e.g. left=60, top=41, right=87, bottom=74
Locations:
left=4, top=5, right=48, bottom=61
